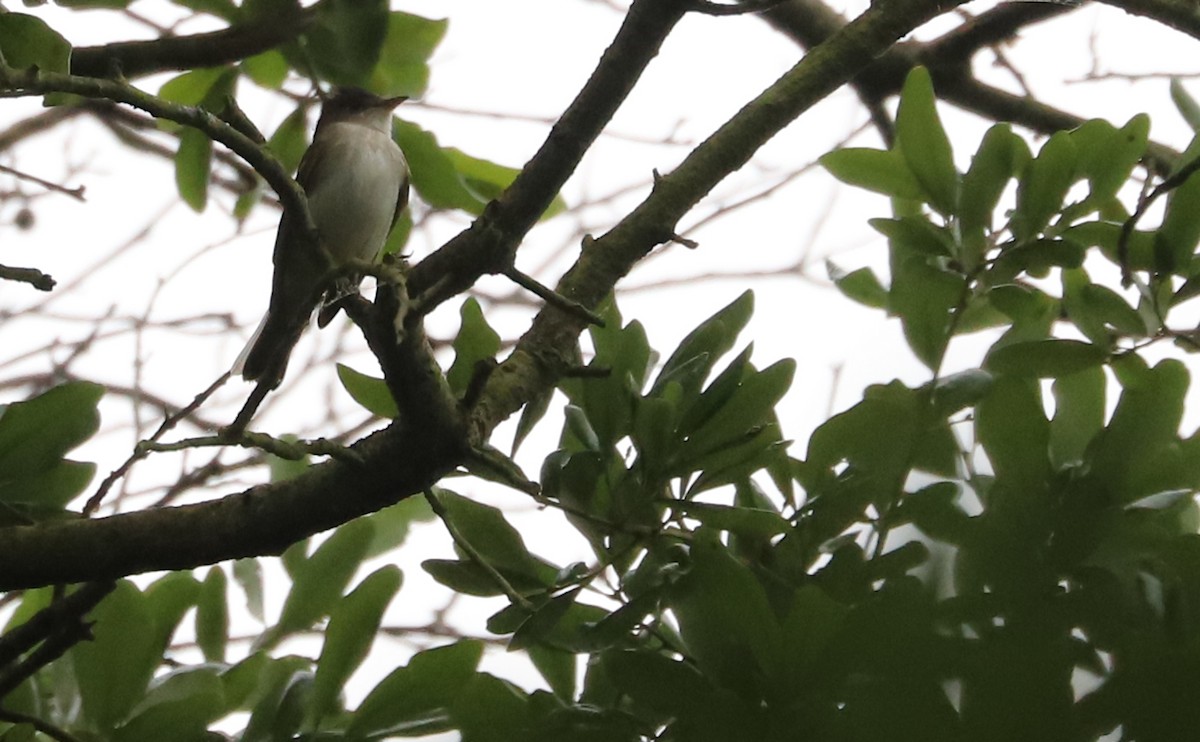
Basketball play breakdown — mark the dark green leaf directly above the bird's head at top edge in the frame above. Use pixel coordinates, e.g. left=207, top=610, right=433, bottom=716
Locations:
left=305, top=0, right=390, bottom=88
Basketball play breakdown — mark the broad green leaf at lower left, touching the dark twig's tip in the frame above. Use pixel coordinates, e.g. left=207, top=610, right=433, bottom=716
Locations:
left=71, top=580, right=162, bottom=730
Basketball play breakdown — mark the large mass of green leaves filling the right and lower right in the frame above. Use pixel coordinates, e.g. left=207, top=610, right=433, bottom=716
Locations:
left=316, top=70, right=1200, bottom=741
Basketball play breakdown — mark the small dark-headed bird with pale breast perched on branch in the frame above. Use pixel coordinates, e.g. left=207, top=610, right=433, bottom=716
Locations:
left=233, top=88, right=409, bottom=388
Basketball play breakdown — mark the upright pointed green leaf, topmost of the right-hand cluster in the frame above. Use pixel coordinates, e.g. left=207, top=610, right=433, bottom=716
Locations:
left=896, top=66, right=959, bottom=214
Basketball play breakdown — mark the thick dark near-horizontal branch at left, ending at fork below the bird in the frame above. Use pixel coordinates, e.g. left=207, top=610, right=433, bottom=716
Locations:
left=0, top=420, right=467, bottom=591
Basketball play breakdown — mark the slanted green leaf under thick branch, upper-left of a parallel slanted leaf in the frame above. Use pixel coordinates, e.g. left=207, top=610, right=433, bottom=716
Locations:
left=258, top=519, right=374, bottom=648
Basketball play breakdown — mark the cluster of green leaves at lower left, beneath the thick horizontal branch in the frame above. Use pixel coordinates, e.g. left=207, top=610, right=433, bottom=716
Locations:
left=4, top=499, right=444, bottom=742
